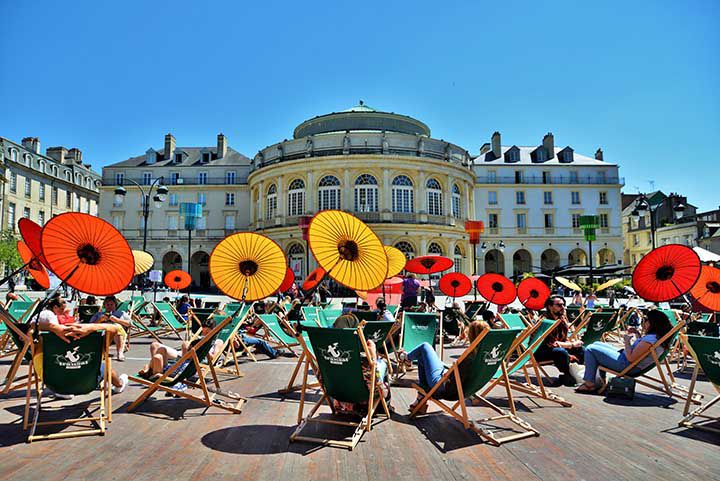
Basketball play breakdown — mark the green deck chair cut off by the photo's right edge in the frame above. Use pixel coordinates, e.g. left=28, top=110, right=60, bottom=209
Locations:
left=679, top=335, right=720, bottom=433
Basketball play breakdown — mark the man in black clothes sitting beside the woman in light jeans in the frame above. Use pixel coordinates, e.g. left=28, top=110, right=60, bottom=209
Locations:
left=535, top=295, right=583, bottom=386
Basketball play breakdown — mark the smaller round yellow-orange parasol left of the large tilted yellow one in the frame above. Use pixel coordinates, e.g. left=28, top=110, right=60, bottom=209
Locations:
left=210, top=232, right=287, bottom=301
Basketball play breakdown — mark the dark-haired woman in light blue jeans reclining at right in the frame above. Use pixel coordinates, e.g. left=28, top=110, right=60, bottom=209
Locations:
left=576, top=309, right=672, bottom=393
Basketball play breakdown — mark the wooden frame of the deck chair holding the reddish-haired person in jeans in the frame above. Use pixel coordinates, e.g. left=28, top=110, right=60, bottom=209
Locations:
left=410, top=329, right=540, bottom=446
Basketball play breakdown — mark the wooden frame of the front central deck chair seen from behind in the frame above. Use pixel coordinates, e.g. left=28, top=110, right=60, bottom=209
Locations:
left=290, top=322, right=390, bottom=451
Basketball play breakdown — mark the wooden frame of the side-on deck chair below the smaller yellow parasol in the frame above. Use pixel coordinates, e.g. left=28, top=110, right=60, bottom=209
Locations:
left=127, top=316, right=247, bottom=414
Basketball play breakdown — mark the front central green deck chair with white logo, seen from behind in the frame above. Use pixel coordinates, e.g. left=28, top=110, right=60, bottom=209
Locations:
left=290, top=327, right=390, bottom=450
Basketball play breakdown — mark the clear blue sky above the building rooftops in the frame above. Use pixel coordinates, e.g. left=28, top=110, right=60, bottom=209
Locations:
left=0, top=0, right=720, bottom=210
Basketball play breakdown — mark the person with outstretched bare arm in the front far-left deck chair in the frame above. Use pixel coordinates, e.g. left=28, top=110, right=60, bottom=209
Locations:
left=35, top=295, right=128, bottom=399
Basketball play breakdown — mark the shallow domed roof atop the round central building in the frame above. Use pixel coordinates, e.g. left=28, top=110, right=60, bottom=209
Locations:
left=293, top=100, right=430, bottom=139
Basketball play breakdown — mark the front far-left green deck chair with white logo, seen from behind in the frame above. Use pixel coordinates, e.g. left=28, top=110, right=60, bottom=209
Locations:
left=23, top=332, right=112, bottom=443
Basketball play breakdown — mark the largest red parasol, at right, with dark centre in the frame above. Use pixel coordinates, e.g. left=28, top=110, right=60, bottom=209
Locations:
left=633, top=244, right=701, bottom=302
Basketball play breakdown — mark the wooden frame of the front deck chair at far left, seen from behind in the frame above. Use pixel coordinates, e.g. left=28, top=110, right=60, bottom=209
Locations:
left=23, top=332, right=113, bottom=443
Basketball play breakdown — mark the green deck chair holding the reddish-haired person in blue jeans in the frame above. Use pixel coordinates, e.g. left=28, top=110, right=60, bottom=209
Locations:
left=410, top=329, right=540, bottom=446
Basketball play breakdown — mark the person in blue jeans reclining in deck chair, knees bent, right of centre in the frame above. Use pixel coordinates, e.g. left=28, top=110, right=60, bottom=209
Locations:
left=398, top=321, right=490, bottom=414
